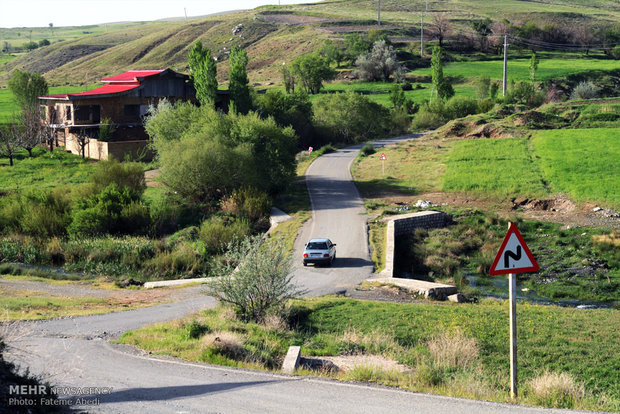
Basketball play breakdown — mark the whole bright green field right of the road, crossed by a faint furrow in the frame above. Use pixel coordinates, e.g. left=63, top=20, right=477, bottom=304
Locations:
left=443, top=128, right=620, bottom=206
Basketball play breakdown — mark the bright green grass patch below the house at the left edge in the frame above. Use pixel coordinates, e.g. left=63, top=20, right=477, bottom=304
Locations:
left=0, top=147, right=94, bottom=192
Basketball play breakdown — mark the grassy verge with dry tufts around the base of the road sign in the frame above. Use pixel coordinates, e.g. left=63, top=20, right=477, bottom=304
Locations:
left=120, top=297, right=620, bottom=411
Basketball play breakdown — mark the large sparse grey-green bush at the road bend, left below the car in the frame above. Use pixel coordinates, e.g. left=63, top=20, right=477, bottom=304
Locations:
left=208, top=236, right=305, bottom=323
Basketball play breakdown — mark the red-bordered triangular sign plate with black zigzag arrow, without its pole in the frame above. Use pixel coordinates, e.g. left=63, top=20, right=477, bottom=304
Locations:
left=489, top=223, right=538, bottom=276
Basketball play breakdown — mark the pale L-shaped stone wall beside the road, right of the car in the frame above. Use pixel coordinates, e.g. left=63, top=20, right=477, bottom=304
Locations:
left=381, top=211, right=452, bottom=277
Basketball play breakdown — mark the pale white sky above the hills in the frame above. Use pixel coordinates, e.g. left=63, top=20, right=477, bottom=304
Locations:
left=0, top=0, right=319, bottom=27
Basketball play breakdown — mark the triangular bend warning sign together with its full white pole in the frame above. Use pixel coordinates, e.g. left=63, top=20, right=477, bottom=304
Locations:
left=489, top=223, right=538, bottom=398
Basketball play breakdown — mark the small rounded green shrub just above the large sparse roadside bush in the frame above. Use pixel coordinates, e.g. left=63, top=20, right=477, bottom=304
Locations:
left=200, top=216, right=251, bottom=253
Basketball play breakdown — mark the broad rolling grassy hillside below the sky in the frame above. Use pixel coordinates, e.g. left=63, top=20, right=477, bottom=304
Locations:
left=0, top=0, right=620, bottom=86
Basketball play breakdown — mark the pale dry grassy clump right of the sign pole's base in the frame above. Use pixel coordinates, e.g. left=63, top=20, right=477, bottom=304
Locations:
left=528, top=371, right=585, bottom=408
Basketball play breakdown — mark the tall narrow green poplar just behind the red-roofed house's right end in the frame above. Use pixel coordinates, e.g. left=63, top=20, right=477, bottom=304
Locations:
left=188, top=40, right=217, bottom=107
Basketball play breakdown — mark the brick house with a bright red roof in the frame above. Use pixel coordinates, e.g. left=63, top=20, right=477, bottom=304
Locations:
left=39, top=69, right=196, bottom=160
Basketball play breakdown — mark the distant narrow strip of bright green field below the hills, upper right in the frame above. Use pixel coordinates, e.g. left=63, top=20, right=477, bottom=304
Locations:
left=411, top=58, right=620, bottom=81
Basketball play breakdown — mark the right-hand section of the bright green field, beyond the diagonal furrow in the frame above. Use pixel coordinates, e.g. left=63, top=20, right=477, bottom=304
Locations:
left=532, top=128, right=620, bottom=206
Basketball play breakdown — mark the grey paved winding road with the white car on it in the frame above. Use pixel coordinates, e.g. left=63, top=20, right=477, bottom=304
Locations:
left=0, top=137, right=584, bottom=414
